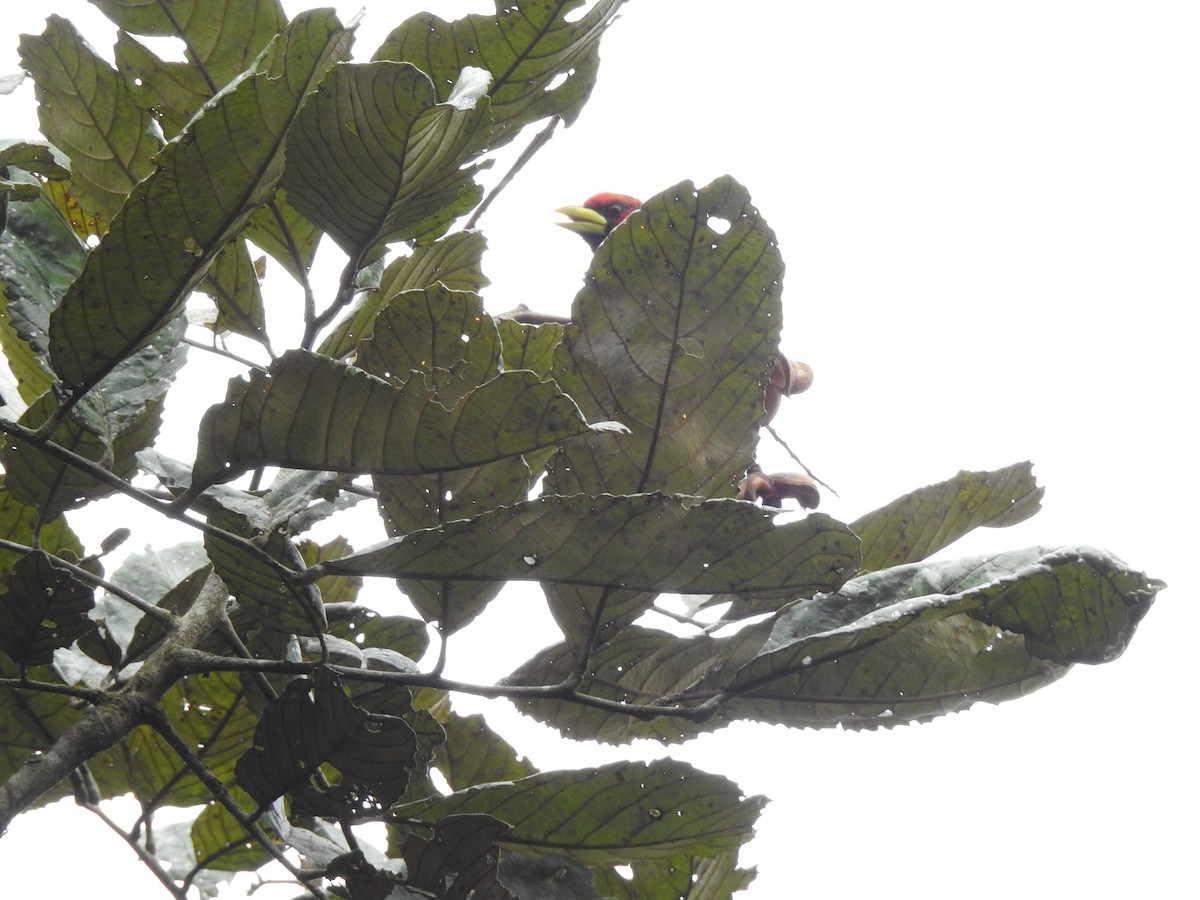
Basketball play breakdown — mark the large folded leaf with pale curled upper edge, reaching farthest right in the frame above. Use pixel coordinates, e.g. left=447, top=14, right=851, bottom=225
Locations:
left=509, top=548, right=1162, bottom=743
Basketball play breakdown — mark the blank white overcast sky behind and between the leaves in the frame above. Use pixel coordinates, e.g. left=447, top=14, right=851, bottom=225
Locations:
left=0, top=0, right=1200, bottom=900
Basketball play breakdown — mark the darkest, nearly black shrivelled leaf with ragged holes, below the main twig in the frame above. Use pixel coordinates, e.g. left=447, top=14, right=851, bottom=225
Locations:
left=238, top=670, right=416, bottom=818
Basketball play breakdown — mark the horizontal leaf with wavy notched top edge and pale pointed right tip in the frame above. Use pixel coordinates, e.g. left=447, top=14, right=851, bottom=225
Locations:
left=193, top=350, right=590, bottom=490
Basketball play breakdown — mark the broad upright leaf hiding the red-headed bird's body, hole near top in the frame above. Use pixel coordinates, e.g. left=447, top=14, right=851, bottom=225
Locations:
left=546, top=178, right=784, bottom=649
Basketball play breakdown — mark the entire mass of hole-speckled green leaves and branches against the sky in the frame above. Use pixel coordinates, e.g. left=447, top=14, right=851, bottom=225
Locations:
left=0, top=0, right=1160, bottom=900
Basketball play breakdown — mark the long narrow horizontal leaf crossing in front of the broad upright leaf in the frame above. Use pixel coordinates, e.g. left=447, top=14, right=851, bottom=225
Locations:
left=313, top=494, right=858, bottom=607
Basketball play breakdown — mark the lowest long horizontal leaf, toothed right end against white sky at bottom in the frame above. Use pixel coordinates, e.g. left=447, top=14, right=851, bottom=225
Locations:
left=389, top=760, right=766, bottom=864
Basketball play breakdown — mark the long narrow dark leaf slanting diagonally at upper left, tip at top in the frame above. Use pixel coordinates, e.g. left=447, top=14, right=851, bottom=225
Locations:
left=49, top=12, right=349, bottom=392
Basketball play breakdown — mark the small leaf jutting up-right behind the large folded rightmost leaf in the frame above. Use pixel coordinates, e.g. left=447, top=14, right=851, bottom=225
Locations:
left=850, top=462, right=1045, bottom=571
